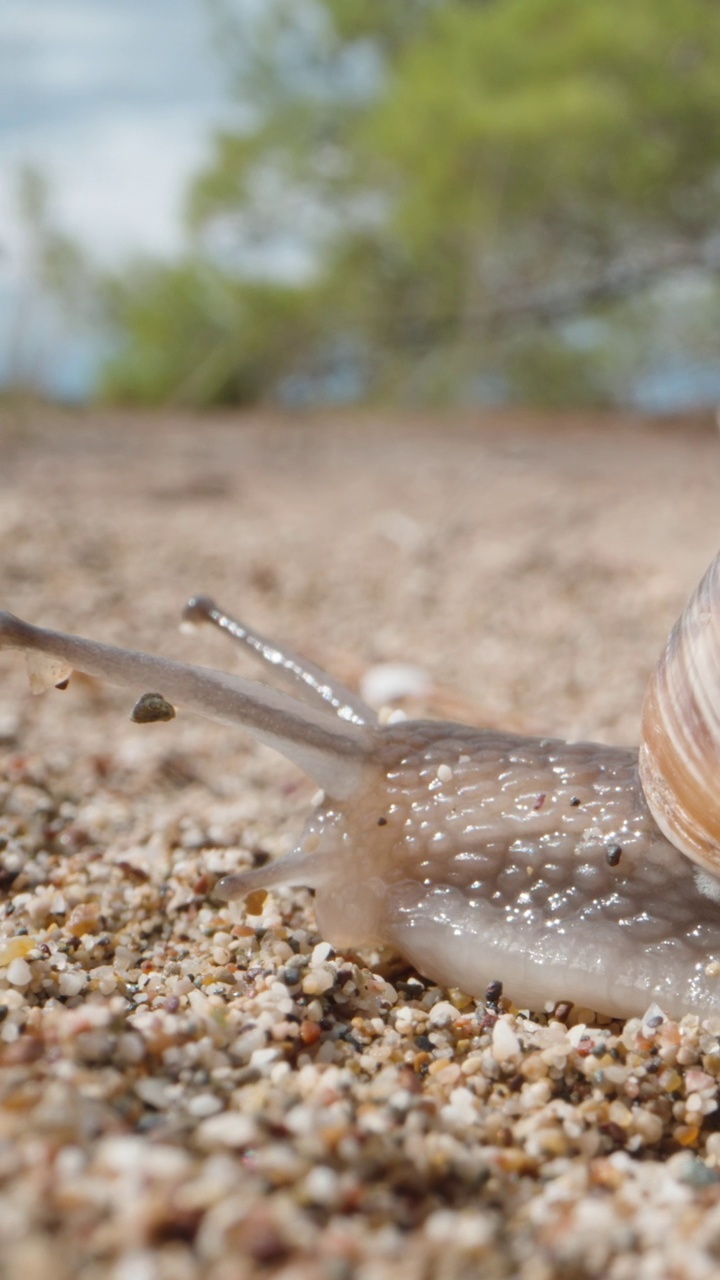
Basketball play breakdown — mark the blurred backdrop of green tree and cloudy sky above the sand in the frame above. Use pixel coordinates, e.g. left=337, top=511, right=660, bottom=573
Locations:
left=0, top=0, right=720, bottom=412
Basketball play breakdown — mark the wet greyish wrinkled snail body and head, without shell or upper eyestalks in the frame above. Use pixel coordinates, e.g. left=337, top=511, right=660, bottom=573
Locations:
left=220, top=722, right=720, bottom=1016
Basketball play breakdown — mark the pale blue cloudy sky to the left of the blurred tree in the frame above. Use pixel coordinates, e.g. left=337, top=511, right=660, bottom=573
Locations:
left=0, top=0, right=242, bottom=398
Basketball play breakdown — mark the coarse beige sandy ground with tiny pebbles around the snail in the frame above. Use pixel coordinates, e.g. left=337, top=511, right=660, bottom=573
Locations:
left=0, top=410, right=720, bottom=1280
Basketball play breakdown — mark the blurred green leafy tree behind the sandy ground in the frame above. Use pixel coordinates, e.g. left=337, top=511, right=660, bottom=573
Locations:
left=99, top=0, right=720, bottom=402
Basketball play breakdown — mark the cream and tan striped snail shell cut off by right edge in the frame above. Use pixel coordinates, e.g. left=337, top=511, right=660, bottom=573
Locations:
left=639, top=554, right=720, bottom=876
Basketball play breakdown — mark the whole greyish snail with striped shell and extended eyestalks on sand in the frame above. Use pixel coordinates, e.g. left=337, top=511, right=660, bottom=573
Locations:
left=0, top=554, right=720, bottom=1016
